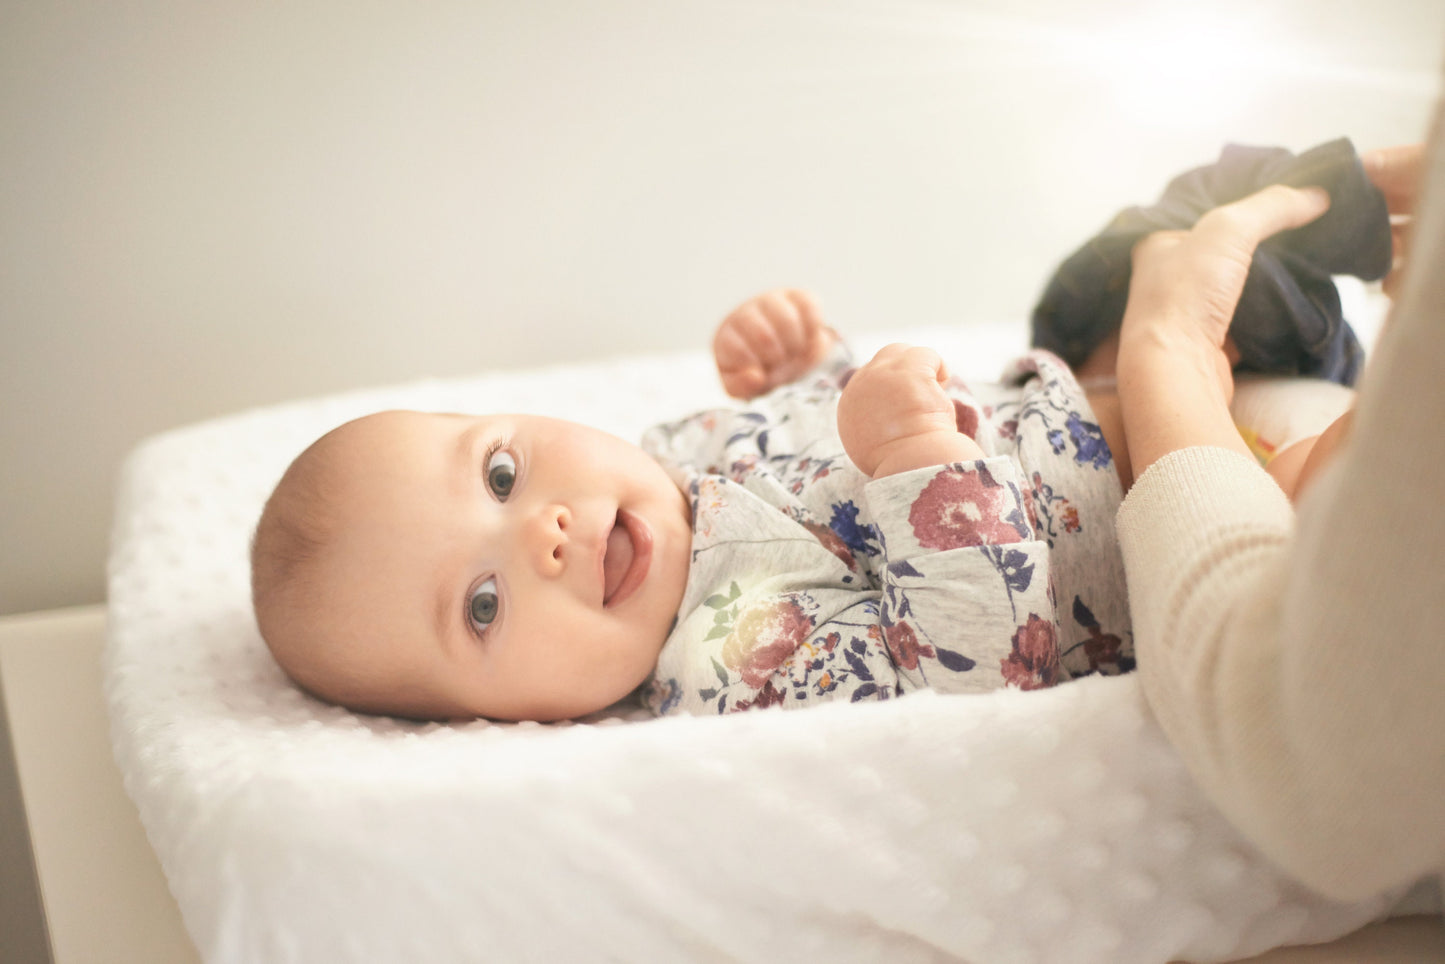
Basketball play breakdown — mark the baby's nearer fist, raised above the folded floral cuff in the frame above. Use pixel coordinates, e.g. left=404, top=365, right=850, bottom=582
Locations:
left=838, top=344, right=984, bottom=478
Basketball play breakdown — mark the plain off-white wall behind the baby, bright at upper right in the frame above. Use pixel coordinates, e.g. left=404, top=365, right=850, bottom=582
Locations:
left=0, top=0, right=1445, bottom=613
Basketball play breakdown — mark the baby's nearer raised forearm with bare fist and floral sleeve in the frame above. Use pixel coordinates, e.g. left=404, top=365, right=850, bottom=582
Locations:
left=838, top=344, right=1064, bottom=692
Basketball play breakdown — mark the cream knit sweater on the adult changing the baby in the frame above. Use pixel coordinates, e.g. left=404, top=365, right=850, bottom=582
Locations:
left=1118, top=114, right=1445, bottom=899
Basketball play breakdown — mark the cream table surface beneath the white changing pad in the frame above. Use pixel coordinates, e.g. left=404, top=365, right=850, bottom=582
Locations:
left=0, top=606, right=1445, bottom=964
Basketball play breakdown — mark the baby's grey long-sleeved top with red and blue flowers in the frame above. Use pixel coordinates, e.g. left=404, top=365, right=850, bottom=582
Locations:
left=642, top=345, right=1133, bottom=715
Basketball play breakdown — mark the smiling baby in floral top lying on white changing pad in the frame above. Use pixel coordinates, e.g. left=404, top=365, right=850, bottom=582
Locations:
left=251, top=291, right=1340, bottom=721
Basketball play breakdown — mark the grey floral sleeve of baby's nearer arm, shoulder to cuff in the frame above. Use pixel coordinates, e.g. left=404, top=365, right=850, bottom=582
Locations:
left=643, top=458, right=1061, bottom=714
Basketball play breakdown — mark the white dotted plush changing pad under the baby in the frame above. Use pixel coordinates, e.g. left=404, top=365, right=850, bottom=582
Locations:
left=105, top=324, right=1396, bottom=964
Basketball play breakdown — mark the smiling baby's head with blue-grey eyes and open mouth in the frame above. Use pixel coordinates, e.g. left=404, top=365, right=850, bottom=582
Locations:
left=251, top=412, right=692, bottom=720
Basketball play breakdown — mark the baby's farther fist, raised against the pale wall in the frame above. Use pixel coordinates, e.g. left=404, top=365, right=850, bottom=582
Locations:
left=712, top=288, right=834, bottom=400
